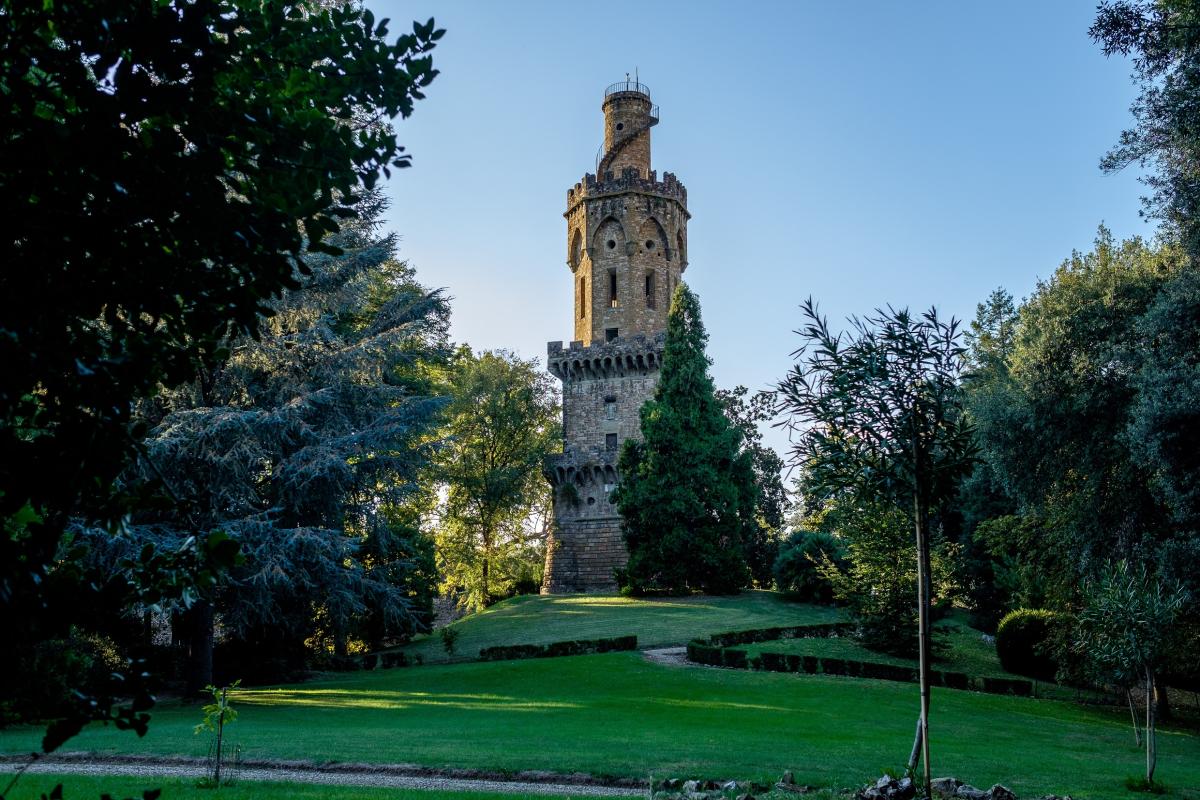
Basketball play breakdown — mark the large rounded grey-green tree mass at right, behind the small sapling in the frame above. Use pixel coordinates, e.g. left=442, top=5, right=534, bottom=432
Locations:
left=966, top=228, right=1200, bottom=607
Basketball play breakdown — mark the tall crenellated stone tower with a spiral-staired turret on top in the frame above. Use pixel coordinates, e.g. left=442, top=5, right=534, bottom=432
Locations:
left=542, top=80, right=691, bottom=593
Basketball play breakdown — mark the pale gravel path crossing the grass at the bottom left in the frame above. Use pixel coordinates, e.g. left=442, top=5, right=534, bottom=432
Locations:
left=0, top=756, right=646, bottom=798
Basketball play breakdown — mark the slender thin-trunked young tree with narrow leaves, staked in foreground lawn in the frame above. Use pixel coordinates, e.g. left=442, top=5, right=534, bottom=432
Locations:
left=778, top=297, right=976, bottom=787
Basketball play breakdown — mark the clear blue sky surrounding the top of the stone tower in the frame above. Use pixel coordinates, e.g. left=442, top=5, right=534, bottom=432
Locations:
left=367, top=0, right=1153, bottom=460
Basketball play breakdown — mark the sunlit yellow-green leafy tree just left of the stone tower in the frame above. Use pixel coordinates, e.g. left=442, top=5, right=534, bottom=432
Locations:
left=432, top=351, right=562, bottom=609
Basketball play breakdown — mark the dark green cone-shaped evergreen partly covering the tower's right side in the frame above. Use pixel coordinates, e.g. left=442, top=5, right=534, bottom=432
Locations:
left=614, top=284, right=760, bottom=594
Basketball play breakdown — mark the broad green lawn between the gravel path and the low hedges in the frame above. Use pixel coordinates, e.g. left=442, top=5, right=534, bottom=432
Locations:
left=0, top=652, right=1200, bottom=800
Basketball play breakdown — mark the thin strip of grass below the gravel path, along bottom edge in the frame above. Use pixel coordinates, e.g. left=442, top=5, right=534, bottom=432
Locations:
left=0, top=772, right=580, bottom=800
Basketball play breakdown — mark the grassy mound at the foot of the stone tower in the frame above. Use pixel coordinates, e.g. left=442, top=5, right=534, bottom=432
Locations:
left=401, top=591, right=839, bottom=663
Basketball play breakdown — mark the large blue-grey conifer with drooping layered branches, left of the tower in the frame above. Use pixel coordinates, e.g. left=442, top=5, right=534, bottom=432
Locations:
left=92, top=194, right=449, bottom=691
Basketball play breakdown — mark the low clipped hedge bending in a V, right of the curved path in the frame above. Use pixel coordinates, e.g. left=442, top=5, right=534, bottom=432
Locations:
left=688, top=622, right=1033, bottom=697
